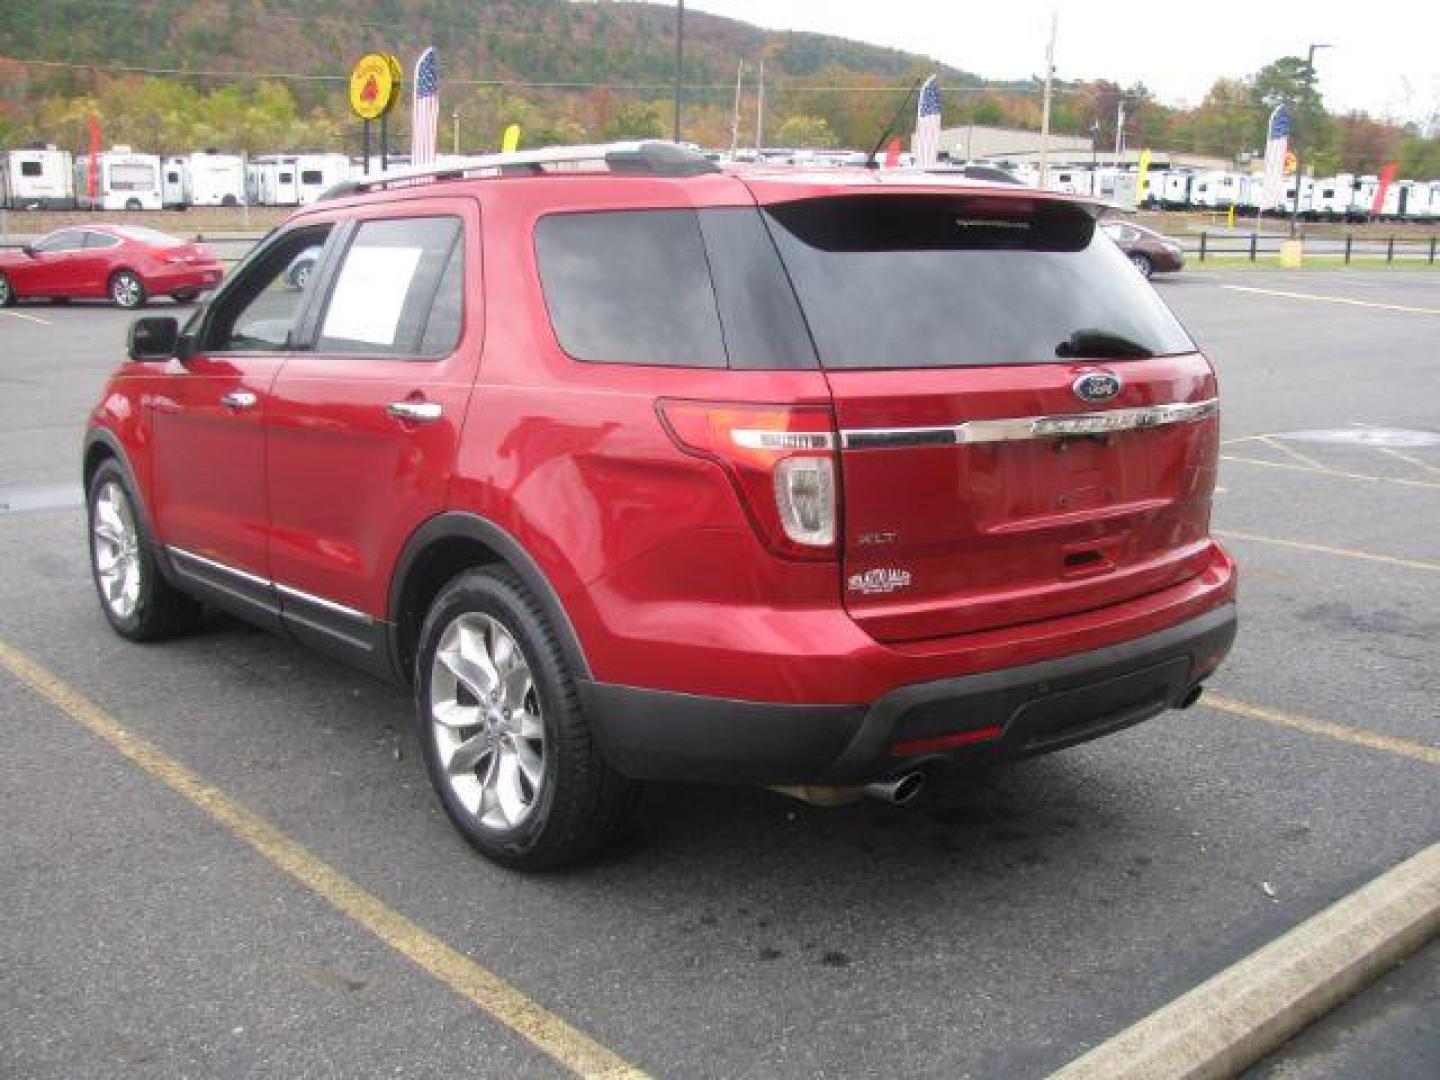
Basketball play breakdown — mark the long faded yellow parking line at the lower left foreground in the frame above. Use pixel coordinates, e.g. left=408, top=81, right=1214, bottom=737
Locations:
left=0, top=641, right=645, bottom=1077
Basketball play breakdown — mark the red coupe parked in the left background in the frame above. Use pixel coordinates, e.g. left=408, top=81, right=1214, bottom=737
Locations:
left=0, top=225, right=225, bottom=308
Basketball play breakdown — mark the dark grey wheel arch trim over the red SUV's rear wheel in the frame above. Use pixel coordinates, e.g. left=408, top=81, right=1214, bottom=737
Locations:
left=387, top=511, right=590, bottom=683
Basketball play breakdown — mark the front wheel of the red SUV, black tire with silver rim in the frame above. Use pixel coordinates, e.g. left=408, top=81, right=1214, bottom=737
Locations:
left=85, top=459, right=200, bottom=641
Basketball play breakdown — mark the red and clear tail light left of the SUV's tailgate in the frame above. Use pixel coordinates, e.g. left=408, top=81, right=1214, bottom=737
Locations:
left=657, top=400, right=840, bottom=559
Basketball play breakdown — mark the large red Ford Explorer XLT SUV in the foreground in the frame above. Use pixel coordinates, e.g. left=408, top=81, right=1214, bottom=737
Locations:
left=84, top=144, right=1236, bottom=867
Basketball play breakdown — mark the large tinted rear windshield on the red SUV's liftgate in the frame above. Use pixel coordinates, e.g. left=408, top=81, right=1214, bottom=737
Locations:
left=766, top=196, right=1194, bottom=369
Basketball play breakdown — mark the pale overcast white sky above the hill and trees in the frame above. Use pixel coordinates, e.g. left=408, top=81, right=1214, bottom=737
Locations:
left=687, top=0, right=1440, bottom=120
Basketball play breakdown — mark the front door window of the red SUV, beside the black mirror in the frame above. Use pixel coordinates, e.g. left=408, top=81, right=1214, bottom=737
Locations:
left=204, top=225, right=330, bottom=353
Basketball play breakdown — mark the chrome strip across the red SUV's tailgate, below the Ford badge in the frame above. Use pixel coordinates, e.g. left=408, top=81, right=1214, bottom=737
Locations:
left=840, top=397, right=1220, bottom=449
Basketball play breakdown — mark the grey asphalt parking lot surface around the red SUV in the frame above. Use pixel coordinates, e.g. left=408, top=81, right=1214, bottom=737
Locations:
left=0, top=271, right=1440, bottom=1077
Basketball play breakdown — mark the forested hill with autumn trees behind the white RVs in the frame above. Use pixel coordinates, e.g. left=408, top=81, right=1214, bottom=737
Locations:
left=0, top=0, right=981, bottom=152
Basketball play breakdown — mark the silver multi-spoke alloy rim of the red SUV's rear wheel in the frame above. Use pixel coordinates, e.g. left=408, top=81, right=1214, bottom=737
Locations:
left=429, top=612, right=546, bottom=829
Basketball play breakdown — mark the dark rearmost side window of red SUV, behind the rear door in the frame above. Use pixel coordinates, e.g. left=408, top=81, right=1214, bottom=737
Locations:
left=534, top=210, right=726, bottom=367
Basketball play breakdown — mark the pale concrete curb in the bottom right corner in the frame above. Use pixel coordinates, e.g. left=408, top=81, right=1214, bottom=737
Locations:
left=1053, top=844, right=1440, bottom=1080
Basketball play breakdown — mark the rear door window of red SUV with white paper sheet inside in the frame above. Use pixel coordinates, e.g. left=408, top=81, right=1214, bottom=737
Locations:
left=315, top=217, right=464, bottom=356
